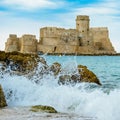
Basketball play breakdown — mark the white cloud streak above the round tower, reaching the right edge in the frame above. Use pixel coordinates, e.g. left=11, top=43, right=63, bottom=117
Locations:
left=74, top=0, right=120, bottom=16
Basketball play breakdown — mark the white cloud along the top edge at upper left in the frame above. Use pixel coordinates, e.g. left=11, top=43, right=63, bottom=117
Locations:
left=0, top=0, right=64, bottom=10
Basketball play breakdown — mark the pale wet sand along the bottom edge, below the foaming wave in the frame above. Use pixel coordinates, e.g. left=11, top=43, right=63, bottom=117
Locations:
left=0, top=107, right=96, bottom=120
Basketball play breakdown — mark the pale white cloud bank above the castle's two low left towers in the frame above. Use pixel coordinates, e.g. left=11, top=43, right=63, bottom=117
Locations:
left=0, top=13, right=66, bottom=50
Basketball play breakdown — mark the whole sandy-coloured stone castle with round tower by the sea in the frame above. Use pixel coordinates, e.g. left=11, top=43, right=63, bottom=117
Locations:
left=5, top=15, right=116, bottom=54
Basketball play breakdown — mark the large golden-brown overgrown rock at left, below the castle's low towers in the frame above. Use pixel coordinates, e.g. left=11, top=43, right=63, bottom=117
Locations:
left=0, top=51, right=41, bottom=72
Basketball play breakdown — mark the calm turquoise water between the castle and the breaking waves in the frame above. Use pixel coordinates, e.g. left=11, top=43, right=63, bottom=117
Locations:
left=45, top=56, right=120, bottom=90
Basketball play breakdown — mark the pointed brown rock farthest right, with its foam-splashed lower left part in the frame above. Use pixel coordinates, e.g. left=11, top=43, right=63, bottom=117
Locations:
left=58, top=65, right=101, bottom=85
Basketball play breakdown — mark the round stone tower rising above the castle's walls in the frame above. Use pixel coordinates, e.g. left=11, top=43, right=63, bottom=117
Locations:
left=76, top=15, right=89, bottom=34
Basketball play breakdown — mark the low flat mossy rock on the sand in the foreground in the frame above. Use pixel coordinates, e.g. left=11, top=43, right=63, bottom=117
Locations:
left=30, top=105, right=57, bottom=113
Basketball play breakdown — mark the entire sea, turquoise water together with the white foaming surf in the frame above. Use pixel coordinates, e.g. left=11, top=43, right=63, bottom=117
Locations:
left=0, top=55, right=120, bottom=120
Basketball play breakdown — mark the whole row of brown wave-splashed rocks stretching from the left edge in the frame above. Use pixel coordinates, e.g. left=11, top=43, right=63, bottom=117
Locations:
left=0, top=52, right=101, bottom=85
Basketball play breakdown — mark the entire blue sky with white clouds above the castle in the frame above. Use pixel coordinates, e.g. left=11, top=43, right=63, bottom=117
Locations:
left=0, top=0, right=120, bottom=52
